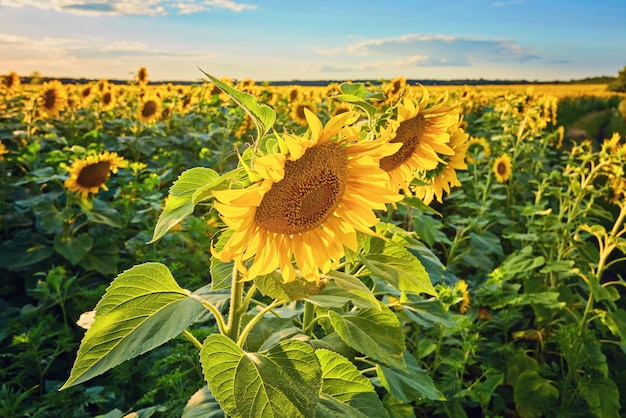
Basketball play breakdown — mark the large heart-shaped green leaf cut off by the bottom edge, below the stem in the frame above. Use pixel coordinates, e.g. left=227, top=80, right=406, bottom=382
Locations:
left=200, top=334, right=322, bottom=417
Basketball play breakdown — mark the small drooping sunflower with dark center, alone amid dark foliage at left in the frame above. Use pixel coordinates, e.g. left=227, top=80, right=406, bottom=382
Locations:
left=65, top=151, right=128, bottom=199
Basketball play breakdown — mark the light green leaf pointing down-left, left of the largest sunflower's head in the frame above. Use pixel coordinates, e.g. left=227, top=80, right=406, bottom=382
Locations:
left=149, top=167, right=222, bottom=243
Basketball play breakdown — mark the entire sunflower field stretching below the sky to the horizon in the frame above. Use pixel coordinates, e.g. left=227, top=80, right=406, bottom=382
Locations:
left=0, top=67, right=626, bottom=418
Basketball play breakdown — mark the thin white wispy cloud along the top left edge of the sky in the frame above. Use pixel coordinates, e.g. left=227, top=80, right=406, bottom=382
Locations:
left=0, top=0, right=257, bottom=16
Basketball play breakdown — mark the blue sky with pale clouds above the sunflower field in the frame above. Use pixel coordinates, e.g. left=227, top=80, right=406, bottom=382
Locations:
left=0, top=0, right=626, bottom=81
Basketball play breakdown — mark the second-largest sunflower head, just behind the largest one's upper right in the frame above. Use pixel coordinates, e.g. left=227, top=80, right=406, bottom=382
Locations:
left=380, top=88, right=459, bottom=193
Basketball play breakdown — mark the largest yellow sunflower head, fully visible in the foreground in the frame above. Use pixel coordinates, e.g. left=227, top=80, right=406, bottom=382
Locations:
left=213, top=109, right=401, bottom=282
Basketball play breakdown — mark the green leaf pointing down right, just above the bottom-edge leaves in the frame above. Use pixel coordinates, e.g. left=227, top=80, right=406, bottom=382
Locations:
left=328, top=303, right=406, bottom=370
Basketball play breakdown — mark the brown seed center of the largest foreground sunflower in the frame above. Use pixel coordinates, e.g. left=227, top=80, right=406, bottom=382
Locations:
left=254, top=142, right=348, bottom=235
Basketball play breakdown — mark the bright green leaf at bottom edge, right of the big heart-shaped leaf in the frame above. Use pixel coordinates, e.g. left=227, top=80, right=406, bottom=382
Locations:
left=315, top=349, right=387, bottom=417
